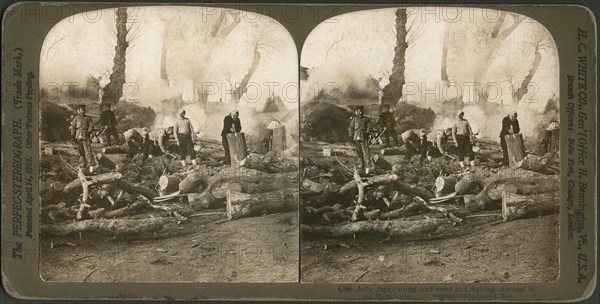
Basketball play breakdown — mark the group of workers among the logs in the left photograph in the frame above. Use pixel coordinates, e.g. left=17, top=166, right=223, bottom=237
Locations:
left=70, top=104, right=242, bottom=172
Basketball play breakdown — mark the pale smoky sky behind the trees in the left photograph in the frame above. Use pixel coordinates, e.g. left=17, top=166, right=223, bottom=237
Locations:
left=40, top=6, right=298, bottom=108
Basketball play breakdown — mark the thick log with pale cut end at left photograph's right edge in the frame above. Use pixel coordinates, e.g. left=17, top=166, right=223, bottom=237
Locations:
left=227, top=189, right=298, bottom=220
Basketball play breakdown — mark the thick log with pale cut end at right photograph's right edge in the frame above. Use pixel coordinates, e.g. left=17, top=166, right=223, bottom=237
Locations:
left=502, top=191, right=560, bottom=222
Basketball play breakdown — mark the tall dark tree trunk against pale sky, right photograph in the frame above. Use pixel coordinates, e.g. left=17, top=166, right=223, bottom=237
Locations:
left=381, top=8, right=408, bottom=105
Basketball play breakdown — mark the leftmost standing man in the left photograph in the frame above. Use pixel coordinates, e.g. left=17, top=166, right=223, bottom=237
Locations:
left=71, top=105, right=96, bottom=173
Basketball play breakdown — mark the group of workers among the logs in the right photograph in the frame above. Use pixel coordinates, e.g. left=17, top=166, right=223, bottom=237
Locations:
left=348, top=105, right=520, bottom=173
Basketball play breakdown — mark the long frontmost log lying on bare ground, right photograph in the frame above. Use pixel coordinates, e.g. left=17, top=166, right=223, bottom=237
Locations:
left=301, top=218, right=451, bottom=238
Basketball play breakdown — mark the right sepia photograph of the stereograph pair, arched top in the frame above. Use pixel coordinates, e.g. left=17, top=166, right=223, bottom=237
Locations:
left=300, top=7, right=560, bottom=283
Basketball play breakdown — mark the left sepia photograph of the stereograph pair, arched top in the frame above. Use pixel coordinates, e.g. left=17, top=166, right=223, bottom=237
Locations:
left=39, top=6, right=299, bottom=282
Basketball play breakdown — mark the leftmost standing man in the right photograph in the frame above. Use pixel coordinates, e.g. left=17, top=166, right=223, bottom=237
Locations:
left=348, top=106, right=372, bottom=174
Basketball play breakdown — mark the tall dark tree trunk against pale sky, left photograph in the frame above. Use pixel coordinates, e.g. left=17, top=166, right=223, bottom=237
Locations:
left=101, top=7, right=129, bottom=106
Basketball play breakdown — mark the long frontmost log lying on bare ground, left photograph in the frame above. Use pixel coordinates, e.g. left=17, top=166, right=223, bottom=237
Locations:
left=41, top=218, right=169, bottom=236
